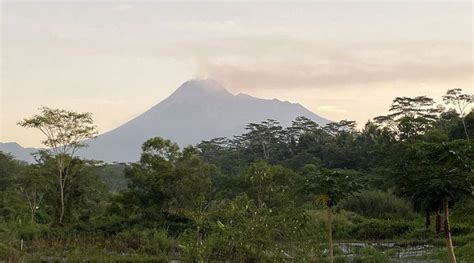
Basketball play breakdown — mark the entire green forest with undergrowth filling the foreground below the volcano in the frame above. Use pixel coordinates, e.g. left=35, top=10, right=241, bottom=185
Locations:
left=0, top=89, right=474, bottom=263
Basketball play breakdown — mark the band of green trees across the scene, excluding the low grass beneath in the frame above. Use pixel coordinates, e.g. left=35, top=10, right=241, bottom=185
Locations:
left=0, top=89, right=474, bottom=262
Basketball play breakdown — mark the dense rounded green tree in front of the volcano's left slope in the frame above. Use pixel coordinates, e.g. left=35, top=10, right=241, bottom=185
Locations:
left=122, top=137, right=215, bottom=234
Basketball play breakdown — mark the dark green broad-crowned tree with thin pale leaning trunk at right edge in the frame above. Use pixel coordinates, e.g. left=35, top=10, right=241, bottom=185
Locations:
left=395, top=140, right=474, bottom=262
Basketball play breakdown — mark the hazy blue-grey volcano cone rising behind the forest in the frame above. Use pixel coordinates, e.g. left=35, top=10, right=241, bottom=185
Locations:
left=79, top=80, right=328, bottom=162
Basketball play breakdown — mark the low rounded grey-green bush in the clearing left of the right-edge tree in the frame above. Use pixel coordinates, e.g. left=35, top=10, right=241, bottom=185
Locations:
left=341, top=191, right=415, bottom=219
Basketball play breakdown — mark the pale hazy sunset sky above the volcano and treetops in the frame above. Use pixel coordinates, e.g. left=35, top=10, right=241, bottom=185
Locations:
left=0, top=1, right=474, bottom=146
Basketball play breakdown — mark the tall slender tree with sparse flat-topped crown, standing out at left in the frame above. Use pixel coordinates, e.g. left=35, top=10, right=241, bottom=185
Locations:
left=18, top=107, right=97, bottom=224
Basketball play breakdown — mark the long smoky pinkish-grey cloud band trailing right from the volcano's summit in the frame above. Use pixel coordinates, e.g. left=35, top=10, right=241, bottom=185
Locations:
left=205, top=57, right=473, bottom=89
